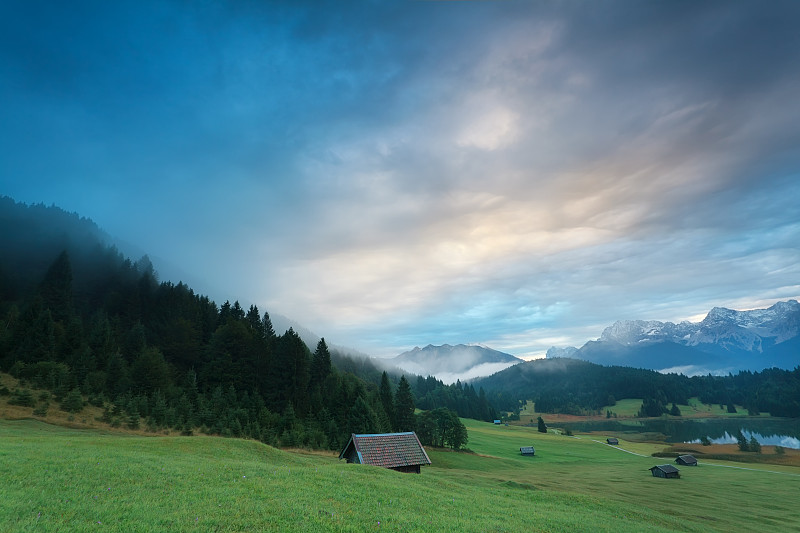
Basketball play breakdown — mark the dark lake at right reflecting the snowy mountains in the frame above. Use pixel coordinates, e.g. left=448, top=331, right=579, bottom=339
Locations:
left=564, top=417, right=800, bottom=449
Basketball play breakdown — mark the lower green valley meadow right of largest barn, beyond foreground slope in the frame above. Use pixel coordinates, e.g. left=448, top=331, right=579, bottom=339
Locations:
left=431, top=421, right=800, bottom=531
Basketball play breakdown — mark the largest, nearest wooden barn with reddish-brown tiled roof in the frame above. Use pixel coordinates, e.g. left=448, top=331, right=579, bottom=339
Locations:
left=339, top=431, right=431, bottom=474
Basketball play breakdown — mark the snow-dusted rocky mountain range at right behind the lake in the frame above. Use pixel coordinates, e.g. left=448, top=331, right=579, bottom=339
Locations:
left=547, top=300, right=800, bottom=375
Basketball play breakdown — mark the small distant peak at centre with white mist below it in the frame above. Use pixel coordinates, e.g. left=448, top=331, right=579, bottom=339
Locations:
left=388, top=344, right=522, bottom=383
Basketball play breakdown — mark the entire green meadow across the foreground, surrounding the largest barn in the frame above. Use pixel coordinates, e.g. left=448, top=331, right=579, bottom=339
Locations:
left=0, top=420, right=800, bottom=531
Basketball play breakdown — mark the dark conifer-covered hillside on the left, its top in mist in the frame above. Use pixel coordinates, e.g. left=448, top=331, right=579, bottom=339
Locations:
left=0, top=198, right=495, bottom=449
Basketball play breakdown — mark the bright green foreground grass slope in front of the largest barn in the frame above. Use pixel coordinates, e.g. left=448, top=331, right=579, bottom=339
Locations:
left=0, top=420, right=688, bottom=531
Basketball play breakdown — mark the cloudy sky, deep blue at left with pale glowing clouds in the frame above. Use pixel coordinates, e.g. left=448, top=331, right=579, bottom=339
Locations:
left=0, top=0, right=800, bottom=358
